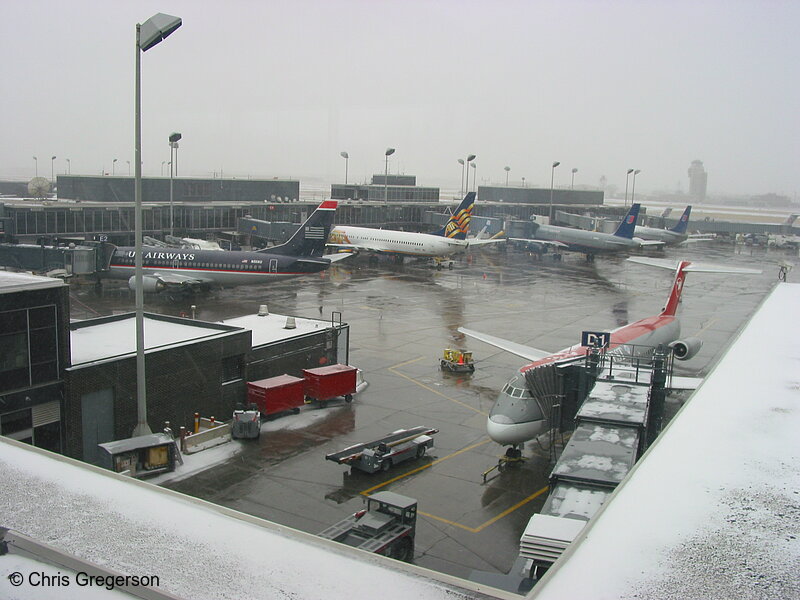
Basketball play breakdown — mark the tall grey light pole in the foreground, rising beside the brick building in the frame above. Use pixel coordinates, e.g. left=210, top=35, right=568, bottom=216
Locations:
left=133, top=13, right=182, bottom=436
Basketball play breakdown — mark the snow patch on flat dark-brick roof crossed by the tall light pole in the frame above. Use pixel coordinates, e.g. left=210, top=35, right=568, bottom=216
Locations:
left=70, top=313, right=242, bottom=366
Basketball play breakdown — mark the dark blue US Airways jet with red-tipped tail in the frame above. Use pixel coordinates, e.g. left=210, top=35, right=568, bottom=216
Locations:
left=105, top=200, right=347, bottom=292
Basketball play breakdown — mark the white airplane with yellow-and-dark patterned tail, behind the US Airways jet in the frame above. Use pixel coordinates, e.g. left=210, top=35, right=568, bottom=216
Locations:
left=328, top=192, right=502, bottom=263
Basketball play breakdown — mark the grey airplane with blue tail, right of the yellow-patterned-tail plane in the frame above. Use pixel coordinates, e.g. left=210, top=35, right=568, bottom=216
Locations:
left=509, top=203, right=664, bottom=262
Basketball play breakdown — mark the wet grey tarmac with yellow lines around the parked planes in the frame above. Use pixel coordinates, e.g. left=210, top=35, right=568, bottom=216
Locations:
left=72, top=244, right=800, bottom=577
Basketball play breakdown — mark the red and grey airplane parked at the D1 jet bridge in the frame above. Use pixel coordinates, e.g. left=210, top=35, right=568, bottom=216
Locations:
left=458, top=257, right=760, bottom=458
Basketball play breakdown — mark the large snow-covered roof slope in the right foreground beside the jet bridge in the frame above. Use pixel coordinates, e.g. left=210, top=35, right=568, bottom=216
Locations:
left=531, top=283, right=800, bottom=600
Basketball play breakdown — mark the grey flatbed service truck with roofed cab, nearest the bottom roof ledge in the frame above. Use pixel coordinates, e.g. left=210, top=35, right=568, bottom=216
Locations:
left=319, top=492, right=417, bottom=562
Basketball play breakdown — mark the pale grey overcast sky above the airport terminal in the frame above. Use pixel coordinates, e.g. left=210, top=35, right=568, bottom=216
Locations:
left=0, top=0, right=800, bottom=197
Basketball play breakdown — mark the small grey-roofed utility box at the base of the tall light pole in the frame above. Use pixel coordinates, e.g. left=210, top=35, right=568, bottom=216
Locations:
left=98, top=433, right=178, bottom=478
